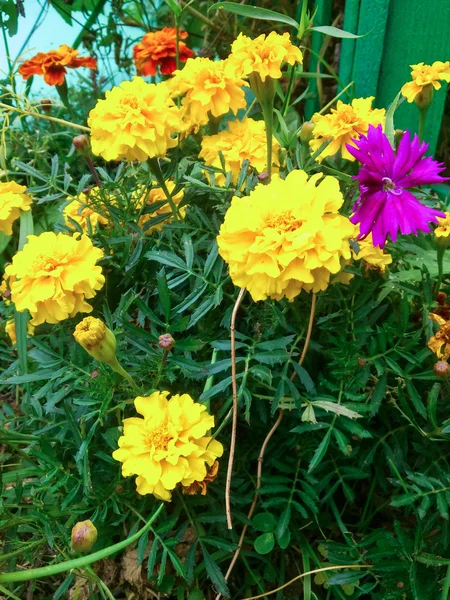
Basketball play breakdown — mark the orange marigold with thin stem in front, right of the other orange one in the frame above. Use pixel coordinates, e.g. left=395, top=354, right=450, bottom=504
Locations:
left=133, top=27, right=195, bottom=75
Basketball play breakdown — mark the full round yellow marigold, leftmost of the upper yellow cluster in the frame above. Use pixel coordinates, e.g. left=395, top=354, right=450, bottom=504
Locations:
left=88, top=77, right=184, bottom=162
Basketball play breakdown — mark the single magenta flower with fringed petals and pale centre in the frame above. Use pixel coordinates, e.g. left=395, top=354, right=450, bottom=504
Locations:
left=347, top=125, right=448, bottom=248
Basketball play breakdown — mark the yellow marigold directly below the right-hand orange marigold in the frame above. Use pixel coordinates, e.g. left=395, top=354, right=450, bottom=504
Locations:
left=168, top=57, right=247, bottom=128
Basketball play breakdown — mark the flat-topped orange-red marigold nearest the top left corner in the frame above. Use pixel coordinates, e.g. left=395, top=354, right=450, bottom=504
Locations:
left=19, top=44, right=97, bottom=85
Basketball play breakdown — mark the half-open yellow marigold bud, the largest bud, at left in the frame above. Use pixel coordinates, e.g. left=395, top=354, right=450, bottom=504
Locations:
left=73, top=317, right=117, bottom=364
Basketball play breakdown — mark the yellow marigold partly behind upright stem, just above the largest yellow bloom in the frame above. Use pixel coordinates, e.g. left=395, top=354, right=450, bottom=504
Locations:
left=199, top=118, right=280, bottom=186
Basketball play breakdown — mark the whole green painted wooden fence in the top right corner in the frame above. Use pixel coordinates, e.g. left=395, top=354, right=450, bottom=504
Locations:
left=306, top=0, right=450, bottom=152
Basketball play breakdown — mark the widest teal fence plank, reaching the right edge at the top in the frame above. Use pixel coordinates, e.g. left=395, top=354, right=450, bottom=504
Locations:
left=376, top=0, right=450, bottom=153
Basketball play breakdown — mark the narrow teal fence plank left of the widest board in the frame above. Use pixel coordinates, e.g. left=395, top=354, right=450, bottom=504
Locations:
left=352, top=0, right=390, bottom=98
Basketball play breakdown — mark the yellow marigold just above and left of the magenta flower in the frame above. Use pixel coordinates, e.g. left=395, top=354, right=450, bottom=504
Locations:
left=309, top=96, right=386, bottom=161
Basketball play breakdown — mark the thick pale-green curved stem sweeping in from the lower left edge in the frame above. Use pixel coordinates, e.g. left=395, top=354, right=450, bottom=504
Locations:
left=0, top=502, right=164, bottom=583
